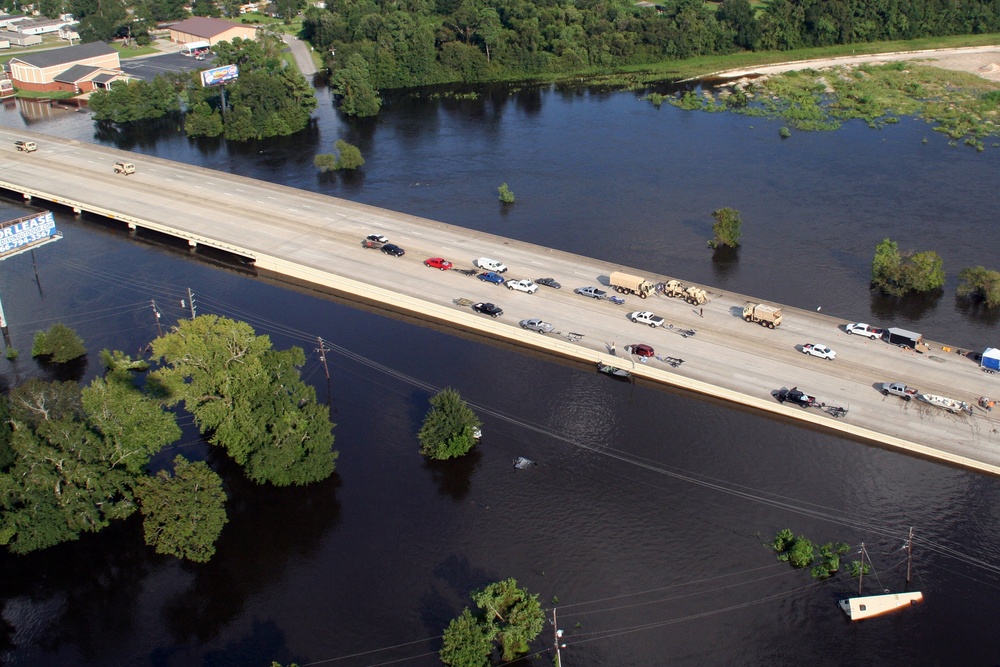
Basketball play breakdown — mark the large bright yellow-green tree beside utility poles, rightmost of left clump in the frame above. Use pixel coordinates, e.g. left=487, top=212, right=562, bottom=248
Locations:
left=152, top=315, right=337, bottom=486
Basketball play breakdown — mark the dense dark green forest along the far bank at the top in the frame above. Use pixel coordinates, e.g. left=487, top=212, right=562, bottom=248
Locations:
left=303, top=0, right=1000, bottom=89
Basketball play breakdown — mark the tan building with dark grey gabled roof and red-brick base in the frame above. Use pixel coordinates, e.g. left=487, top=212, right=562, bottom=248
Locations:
left=9, top=42, right=128, bottom=93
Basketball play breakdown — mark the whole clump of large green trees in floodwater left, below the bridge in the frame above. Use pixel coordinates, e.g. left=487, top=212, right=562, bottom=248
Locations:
left=0, top=316, right=337, bottom=562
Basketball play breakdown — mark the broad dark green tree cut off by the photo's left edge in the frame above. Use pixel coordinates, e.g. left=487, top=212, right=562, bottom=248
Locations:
left=0, top=376, right=180, bottom=553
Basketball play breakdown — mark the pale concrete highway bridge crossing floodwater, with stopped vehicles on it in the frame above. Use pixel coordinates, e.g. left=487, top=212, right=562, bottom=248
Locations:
left=0, top=129, right=1000, bottom=473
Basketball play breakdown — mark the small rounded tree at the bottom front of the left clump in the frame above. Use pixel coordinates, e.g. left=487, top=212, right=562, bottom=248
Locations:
left=135, top=456, right=228, bottom=563
